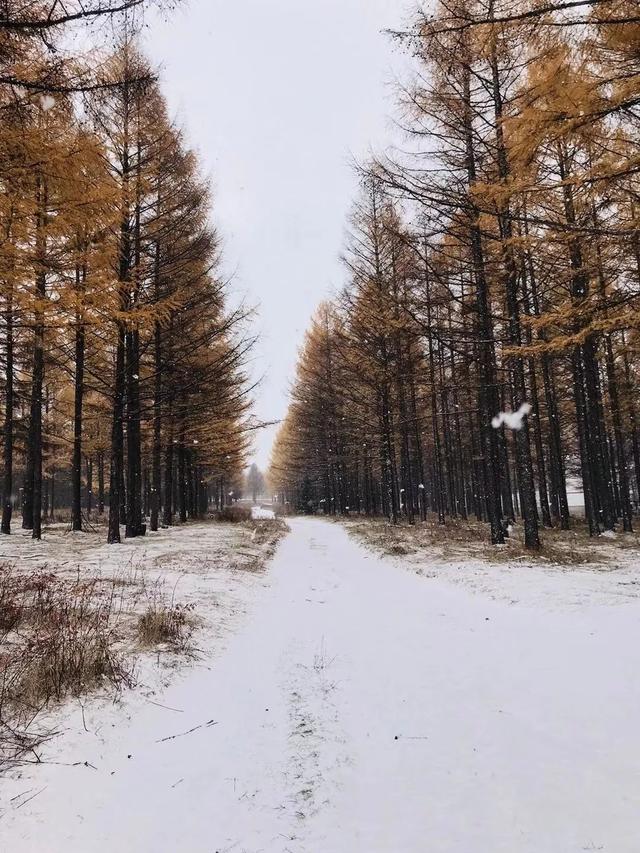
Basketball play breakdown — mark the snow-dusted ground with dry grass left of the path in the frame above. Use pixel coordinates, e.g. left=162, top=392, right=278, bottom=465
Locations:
left=0, top=515, right=286, bottom=776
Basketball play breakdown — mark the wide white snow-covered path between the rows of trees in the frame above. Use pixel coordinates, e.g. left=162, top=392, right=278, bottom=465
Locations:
left=0, top=519, right=640, bottom=853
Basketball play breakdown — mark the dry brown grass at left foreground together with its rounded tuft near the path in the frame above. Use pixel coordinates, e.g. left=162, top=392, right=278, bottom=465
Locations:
left=0, top=565, right=195, bottom=769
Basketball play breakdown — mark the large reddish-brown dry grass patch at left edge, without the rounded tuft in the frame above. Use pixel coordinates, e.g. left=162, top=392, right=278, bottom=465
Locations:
left=0, top=566, right=138, bottom=767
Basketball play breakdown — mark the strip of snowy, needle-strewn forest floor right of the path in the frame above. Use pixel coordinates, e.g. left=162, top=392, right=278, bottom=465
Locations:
left=342, top=516, right=640, bottom=612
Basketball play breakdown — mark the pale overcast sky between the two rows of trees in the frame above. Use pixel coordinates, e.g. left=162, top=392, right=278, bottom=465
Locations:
left=146, top=0, right=407, bottom=468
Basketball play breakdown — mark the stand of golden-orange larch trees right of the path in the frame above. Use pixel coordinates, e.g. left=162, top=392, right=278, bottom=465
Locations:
left=269, top=0, right=640, bottom=550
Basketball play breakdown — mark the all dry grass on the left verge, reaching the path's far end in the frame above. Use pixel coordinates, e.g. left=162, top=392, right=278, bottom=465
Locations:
left=0, top=508, right=287, bottom=770
